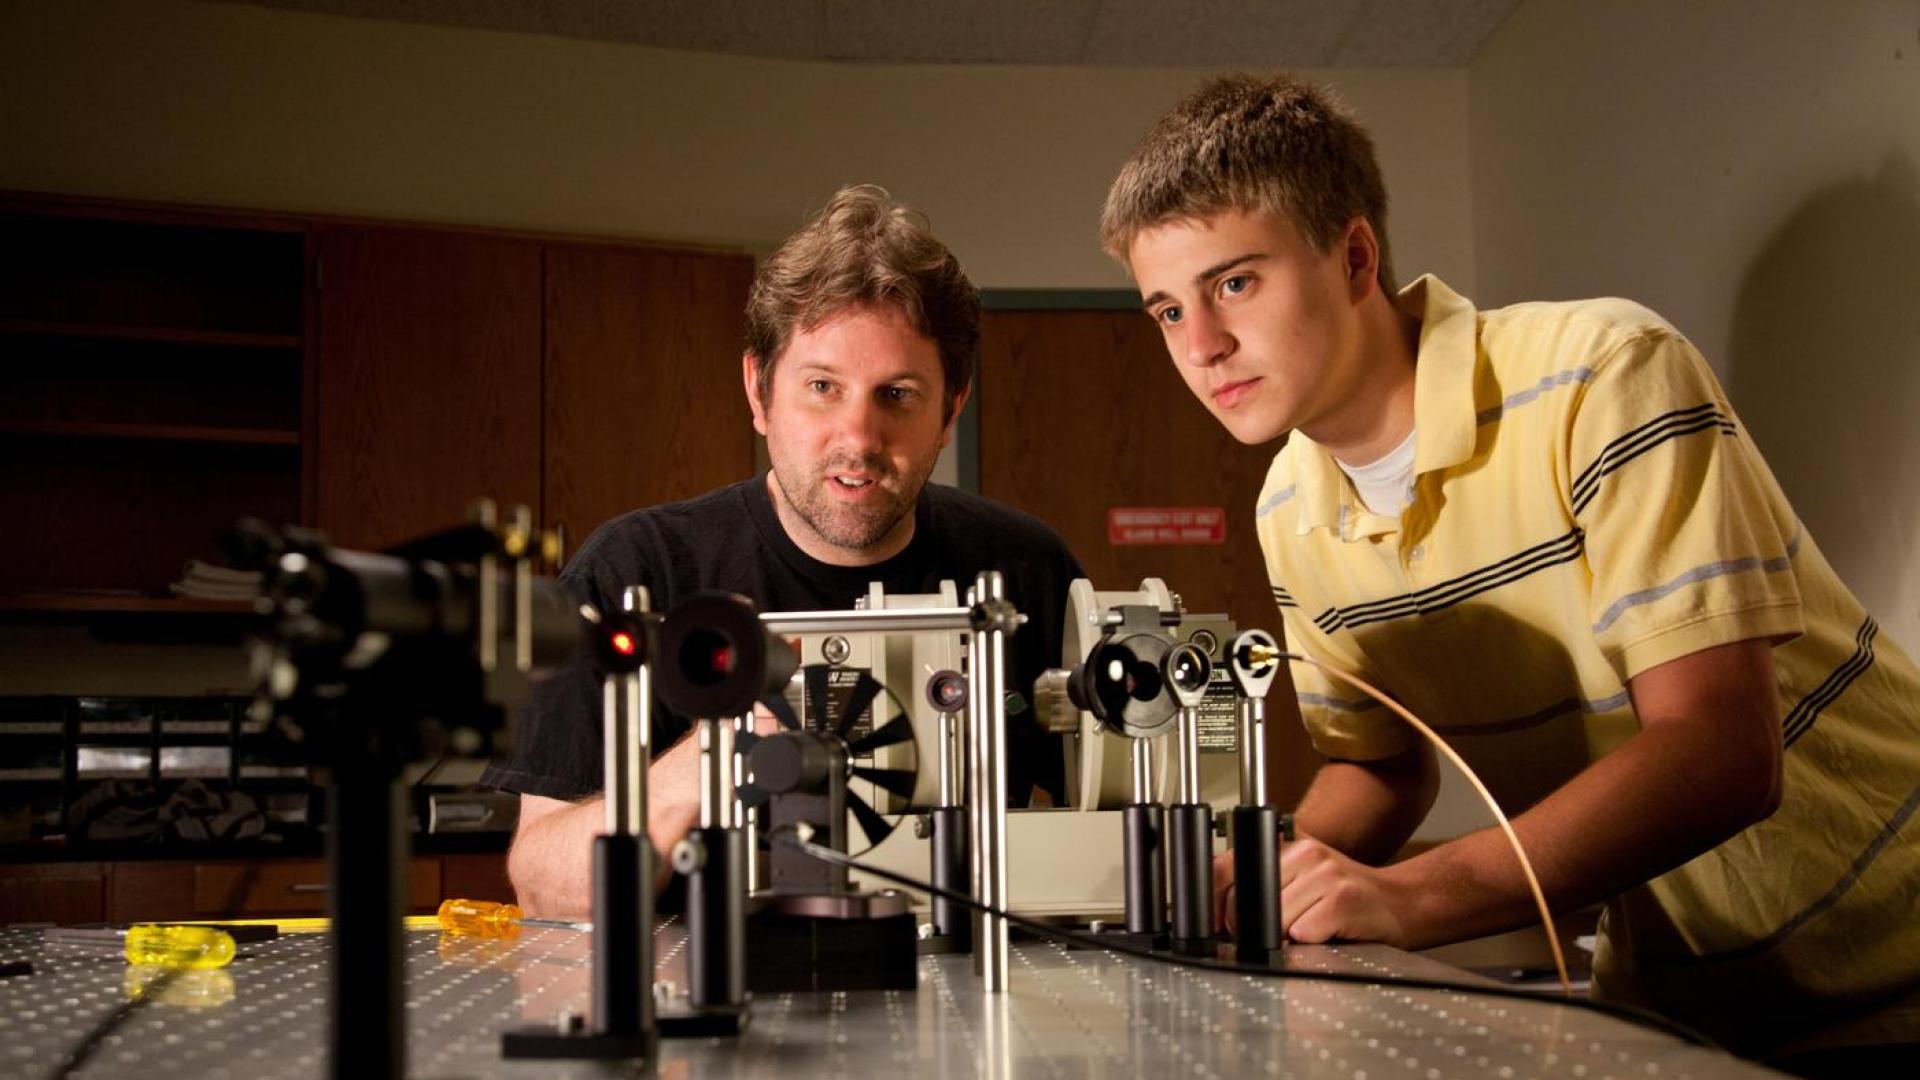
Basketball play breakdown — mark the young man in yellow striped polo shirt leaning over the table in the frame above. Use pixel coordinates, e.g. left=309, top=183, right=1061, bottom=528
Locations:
left=1102, top=77, right=1920, bottom=1061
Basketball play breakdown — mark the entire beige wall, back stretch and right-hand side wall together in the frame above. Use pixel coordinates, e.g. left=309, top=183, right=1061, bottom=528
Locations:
left=11, top=0, right=1920, bottom=707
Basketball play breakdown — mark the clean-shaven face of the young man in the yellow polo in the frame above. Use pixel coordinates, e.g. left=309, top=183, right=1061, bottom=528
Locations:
left=1127, top=209, right=1363, bottom=446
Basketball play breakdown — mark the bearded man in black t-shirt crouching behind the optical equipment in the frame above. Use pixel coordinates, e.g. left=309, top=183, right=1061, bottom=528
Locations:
left=484, top=186, right=1081, bottom=917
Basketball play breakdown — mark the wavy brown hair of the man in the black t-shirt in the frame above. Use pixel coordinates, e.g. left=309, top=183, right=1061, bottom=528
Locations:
left=747, top=184, right=979, bottom=421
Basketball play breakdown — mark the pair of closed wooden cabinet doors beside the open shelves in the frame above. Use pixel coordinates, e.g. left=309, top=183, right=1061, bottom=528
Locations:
left=317, top=227, right=753, bottom=548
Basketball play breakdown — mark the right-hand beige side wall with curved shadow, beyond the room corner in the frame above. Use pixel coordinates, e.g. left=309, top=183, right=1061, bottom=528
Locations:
left=1471, top=0, right=1920, bottom=651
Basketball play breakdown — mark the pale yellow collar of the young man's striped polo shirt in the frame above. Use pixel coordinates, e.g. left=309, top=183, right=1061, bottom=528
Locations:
left=1288, top=275, right=1480, bottom=540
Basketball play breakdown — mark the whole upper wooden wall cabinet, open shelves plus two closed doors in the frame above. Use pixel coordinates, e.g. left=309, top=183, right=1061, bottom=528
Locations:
left=0, top=196, right=755, bottom=613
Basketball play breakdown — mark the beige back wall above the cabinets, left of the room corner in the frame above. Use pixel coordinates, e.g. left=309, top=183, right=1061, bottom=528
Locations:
left=0, top=0, right=1473, bottom=288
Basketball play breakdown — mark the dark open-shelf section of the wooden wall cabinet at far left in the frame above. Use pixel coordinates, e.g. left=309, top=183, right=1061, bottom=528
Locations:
left=0, top=198, right=307, bottom=605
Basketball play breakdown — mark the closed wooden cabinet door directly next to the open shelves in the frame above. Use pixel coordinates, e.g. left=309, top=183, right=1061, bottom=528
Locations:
left=313, top=227, right=541, bottom=550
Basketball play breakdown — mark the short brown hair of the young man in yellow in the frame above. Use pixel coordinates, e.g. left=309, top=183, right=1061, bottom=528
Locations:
left=1100, top=75, right=1394, bottom=294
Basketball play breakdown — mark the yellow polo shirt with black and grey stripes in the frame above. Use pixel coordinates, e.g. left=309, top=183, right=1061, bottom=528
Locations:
left=1256, top=277, right=1920, bottom=1053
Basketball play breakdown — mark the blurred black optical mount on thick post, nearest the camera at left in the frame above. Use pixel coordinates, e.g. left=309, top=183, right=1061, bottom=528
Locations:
left=228, top=503, right=582, bottom=1080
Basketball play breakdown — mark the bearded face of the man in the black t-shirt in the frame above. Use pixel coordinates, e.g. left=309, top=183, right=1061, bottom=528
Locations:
left=745, top=306, right=966, bottom=567
